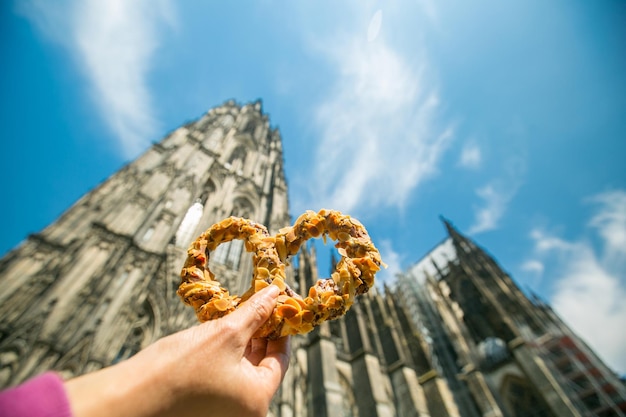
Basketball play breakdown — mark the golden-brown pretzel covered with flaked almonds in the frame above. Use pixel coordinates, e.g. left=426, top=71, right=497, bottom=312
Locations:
left=177, top=209, right=385, bottom=339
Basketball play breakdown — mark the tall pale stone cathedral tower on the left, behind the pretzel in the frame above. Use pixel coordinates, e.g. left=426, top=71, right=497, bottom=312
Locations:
left=0, top=102, right=290, bottom=386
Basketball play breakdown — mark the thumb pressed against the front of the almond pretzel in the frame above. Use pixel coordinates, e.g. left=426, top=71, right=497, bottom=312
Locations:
left=223, top=285, right=280, bottom=343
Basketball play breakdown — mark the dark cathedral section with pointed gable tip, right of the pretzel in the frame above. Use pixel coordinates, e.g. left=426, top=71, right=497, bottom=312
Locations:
left=395, top=220, right=626, bottom=417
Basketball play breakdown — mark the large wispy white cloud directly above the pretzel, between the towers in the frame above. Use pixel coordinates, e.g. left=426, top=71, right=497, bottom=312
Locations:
left=302, top=11, right=453, bottom=216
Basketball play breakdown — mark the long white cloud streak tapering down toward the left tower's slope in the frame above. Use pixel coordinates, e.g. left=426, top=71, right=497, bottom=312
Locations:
left=18, top=0, right=175, bottom=158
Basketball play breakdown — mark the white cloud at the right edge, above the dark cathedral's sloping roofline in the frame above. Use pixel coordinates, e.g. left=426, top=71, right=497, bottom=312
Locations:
left=531, top=191, right=626, bottom=374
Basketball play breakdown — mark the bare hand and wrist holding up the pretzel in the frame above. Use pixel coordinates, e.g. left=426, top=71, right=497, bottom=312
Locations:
left=66, top=285, right=289, bottom=417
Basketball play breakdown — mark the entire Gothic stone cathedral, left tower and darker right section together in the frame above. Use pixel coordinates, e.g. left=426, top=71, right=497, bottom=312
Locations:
left=0, top=101, right=626, bottom=417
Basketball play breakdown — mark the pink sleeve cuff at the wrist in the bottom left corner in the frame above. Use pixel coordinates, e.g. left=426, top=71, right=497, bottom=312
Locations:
left=0, top=372, right=72, bottom=417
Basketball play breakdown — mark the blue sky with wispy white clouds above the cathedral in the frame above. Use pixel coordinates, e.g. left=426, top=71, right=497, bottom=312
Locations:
left=0, top=0, right=626, bottom=375
